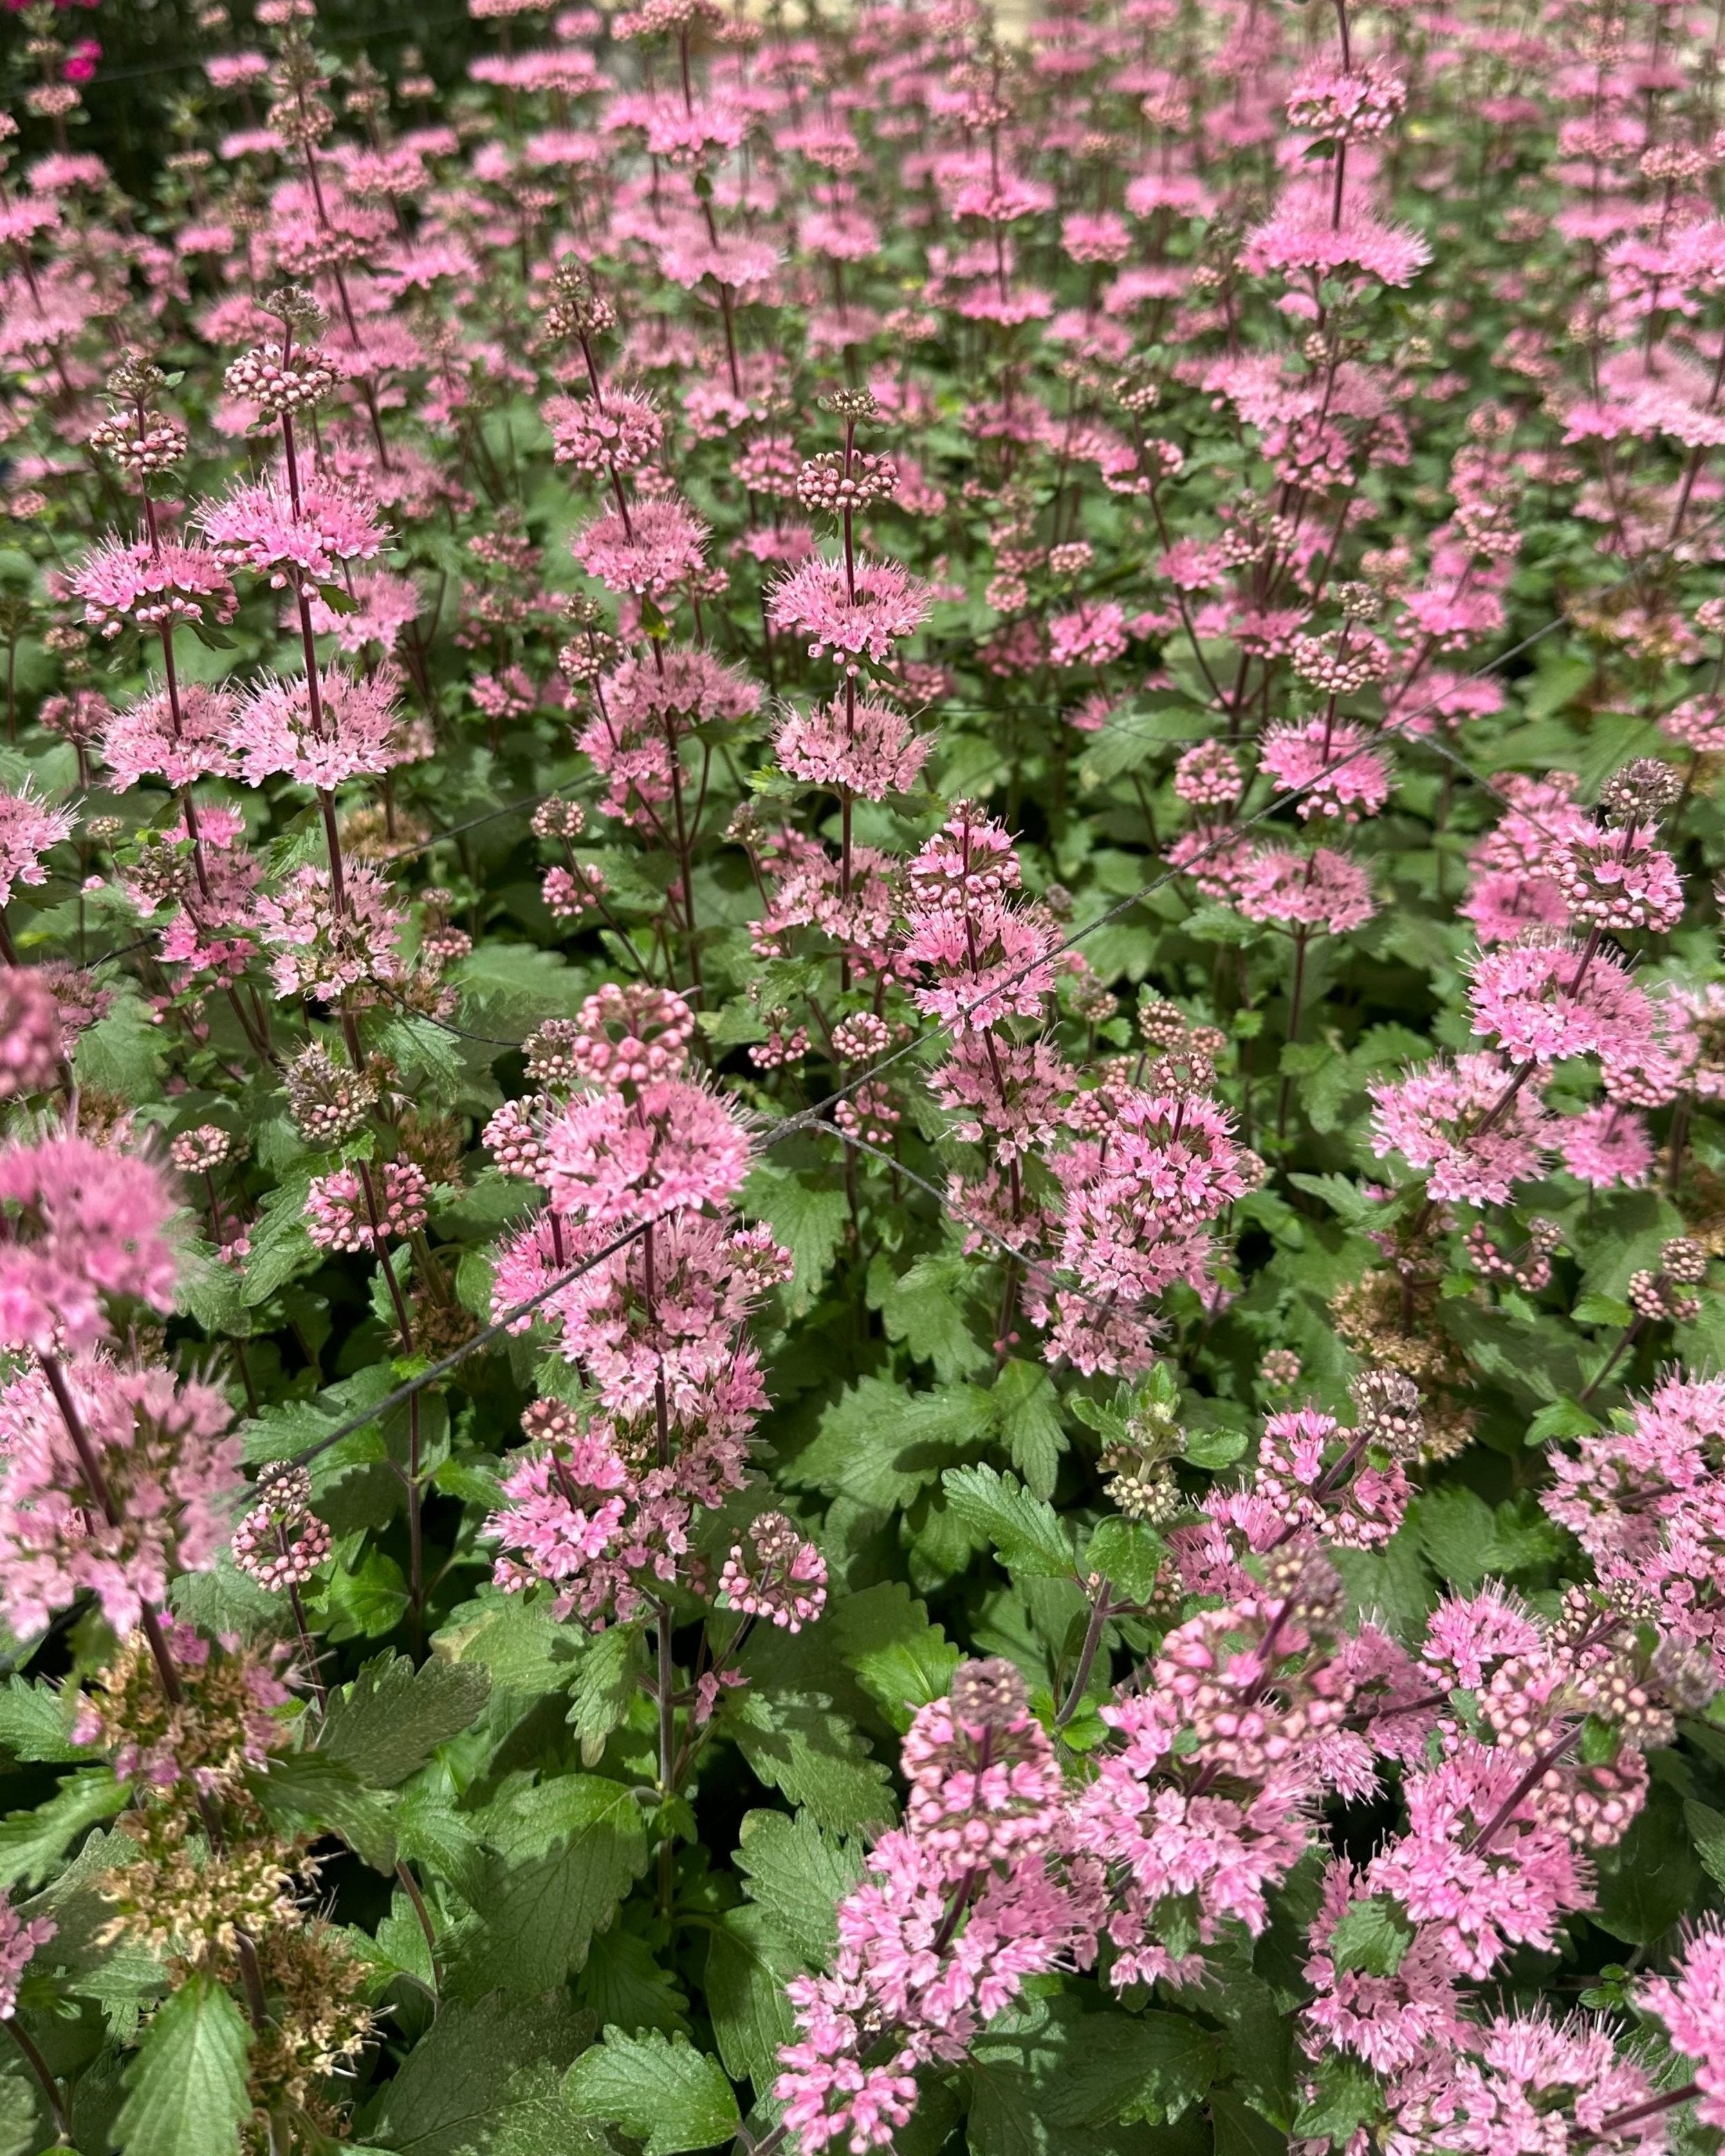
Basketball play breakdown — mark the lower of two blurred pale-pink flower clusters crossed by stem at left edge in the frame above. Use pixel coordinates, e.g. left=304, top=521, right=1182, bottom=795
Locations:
left=0, top=1361, right=243, bottom=1637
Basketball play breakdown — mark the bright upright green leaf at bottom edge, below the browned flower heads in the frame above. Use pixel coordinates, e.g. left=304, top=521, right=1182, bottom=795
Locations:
left=116, top=1977, right=252, bottom=2156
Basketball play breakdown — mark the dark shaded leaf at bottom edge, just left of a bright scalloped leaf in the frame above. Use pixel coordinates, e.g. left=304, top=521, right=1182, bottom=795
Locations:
left=362, top=1992, right=606, bottom=2156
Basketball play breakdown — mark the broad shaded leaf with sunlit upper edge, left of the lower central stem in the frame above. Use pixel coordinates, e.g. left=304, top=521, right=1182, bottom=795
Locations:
left=451, top=1774, right=647, bottom=1998
